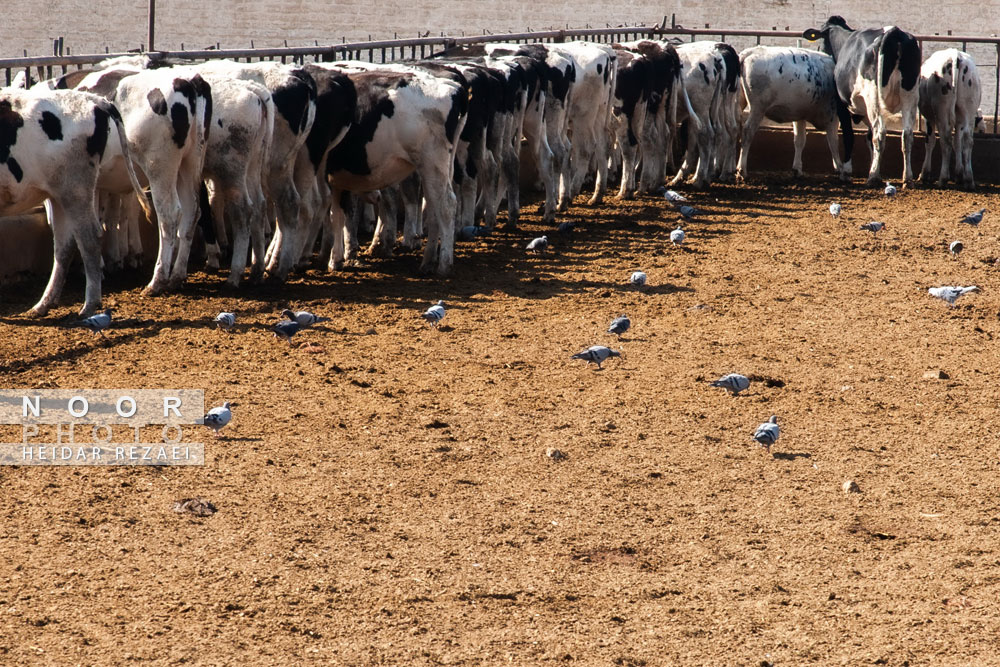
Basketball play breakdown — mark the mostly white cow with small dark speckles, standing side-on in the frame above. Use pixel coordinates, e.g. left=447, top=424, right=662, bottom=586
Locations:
left=736, top=46, right=854, bottom=181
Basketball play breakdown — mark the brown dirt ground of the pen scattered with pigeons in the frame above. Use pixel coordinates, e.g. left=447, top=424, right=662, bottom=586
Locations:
left=0, top=176, right=1000, bottom=665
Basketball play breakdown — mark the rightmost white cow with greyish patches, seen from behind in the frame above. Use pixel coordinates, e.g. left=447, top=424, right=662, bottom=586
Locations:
left=920, top=49, right=982, bottom=190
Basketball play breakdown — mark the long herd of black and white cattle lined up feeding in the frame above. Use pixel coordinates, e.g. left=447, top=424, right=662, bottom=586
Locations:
left=0, top=16, right=980, bottom=315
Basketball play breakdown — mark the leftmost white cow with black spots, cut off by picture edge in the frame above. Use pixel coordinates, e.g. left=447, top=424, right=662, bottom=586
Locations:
left=0, top=88, right=141, bottom=315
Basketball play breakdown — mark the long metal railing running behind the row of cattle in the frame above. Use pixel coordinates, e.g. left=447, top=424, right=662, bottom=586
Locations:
left=0, top=17, right=1000, bottom=134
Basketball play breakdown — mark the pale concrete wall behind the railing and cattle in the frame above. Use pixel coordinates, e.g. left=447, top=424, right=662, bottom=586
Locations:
left=0, top=0, right=997, bottom=56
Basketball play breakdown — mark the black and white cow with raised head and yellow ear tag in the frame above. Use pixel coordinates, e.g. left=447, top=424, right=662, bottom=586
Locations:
left=802, top=16, right=921, bottom=187
